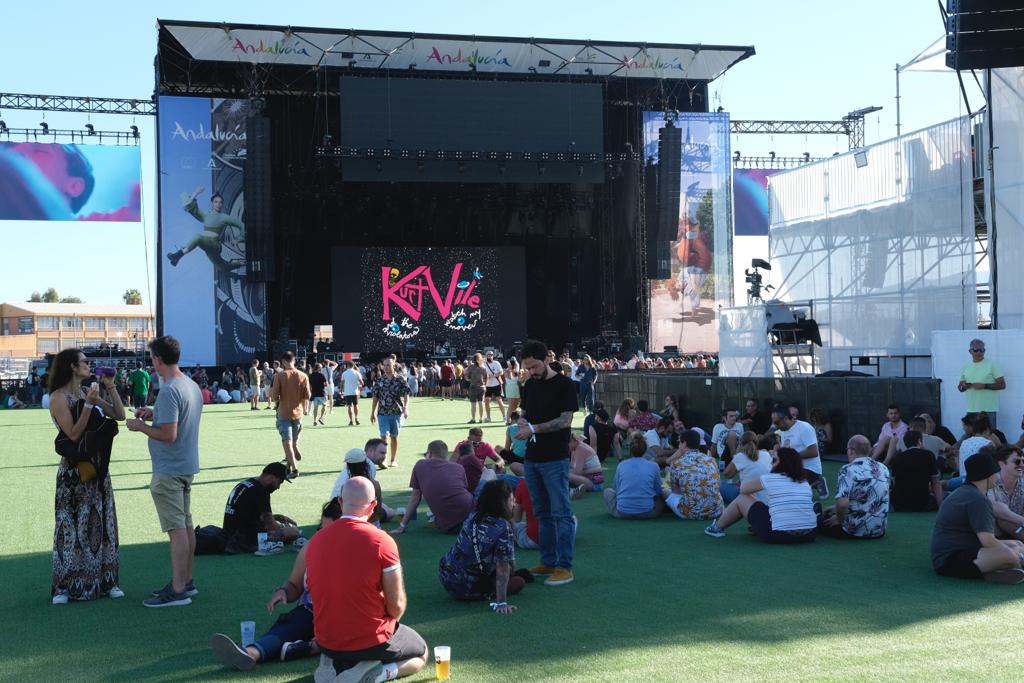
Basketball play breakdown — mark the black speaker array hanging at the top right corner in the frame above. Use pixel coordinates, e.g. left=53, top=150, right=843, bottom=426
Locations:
left=946, top=0, right=1024, bottom=71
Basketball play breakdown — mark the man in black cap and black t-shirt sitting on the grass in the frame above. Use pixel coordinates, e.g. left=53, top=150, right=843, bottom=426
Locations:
left=222, top=463, right=299, bottom=553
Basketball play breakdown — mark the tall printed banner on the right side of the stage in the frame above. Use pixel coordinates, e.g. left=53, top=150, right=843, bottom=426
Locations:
left=643, top=112, right=732, bottom=352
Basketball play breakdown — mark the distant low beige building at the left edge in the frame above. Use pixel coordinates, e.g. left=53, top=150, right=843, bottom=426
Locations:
left=0, top=302, right=156, bottom=358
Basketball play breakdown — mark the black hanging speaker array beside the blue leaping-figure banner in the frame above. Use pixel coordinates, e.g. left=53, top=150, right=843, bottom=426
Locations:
left=245, top=114, right=274, bottom=283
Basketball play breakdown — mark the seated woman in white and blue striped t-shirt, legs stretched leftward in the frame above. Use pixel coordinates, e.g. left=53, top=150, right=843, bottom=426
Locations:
left=705, top=447, right=817, bottom=544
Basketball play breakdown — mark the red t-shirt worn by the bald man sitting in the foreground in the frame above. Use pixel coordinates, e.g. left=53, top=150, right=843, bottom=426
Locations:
left=306, top=518, right=400, bottom=652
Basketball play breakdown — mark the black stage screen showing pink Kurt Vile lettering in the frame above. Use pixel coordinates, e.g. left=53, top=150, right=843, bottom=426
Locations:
left=332, top=247, right=526, bottom=352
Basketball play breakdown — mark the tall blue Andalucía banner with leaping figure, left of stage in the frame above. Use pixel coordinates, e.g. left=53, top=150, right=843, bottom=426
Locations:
left=158, top=96, right=266, bottom=366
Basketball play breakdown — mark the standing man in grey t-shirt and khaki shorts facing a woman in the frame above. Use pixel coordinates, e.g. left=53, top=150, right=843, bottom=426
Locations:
left=127, top=337, right=203, bottom=607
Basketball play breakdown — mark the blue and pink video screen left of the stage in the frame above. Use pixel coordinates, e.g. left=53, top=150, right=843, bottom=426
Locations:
left=0, top=141, right=141, bottom=222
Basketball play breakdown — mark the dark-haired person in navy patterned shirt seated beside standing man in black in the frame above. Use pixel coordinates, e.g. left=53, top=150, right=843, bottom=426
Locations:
left=439, top=479, right=525, bottom=614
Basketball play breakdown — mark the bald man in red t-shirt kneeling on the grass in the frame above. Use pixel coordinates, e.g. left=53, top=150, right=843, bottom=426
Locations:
left=306, top=477, right=427, bottom=683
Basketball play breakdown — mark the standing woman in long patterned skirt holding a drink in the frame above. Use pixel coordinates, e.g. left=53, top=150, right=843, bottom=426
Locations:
left=49, top=348, right=125, bottom=605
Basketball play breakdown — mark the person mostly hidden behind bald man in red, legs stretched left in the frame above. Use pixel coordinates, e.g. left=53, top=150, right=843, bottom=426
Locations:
left=210, top=499, right=341, bottom=671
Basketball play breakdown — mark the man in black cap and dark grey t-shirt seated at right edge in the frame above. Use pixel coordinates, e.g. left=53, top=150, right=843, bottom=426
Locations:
left=932, top=447, right=1024, bottom=584
